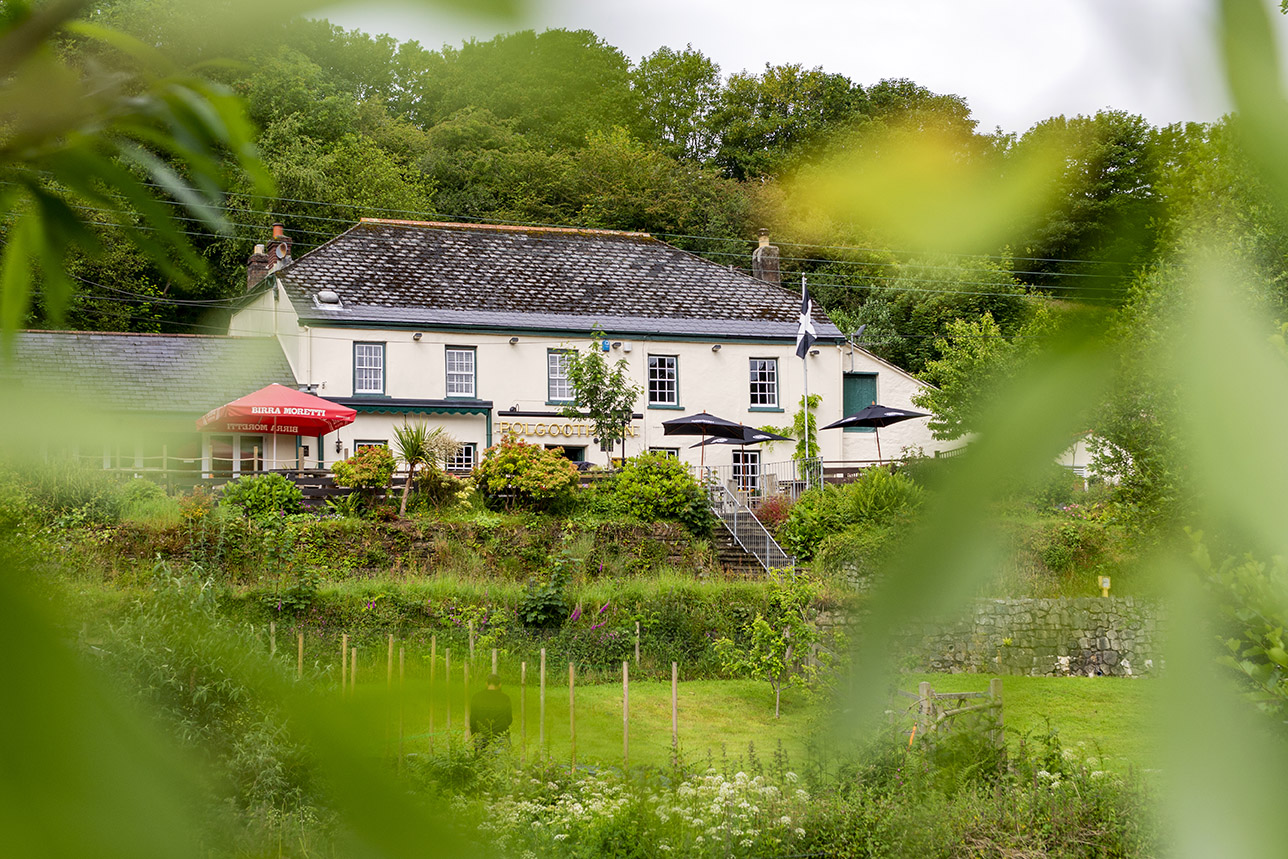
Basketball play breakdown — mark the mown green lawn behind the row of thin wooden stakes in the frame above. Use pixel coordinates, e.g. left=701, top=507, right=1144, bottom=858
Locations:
left=358, top=674, right=1158, bottom=773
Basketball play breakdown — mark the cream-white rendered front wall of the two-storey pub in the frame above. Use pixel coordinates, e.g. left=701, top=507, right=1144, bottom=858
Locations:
left=231, top=292, right=956, bottom=465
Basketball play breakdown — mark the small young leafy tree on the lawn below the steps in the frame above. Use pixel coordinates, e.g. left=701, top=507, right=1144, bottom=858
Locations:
left=715, top=571, right=818, bottom=719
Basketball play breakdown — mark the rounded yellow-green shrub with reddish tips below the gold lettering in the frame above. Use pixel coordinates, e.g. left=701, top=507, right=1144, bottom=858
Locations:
left=474, top=438, right=577, bottom=511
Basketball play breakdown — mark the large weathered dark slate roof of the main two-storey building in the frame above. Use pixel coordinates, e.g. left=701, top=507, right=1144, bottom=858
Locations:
left=279, top=219, right=841, bottom=340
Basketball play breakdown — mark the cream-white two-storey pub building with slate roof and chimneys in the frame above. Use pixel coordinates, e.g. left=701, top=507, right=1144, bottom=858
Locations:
left=226, top=219, right=942, bottom=489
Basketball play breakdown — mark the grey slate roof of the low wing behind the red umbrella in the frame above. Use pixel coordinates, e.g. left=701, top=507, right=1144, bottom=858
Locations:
left=10, top=331, right=296, bottom=417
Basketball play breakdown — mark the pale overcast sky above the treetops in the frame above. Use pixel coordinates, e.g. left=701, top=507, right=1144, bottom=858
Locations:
left=325, top=0, right=1288, bottom=133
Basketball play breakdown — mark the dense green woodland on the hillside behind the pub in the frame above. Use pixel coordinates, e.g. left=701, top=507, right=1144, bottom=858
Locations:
left=15, top=0, right=1288, bottom=528
